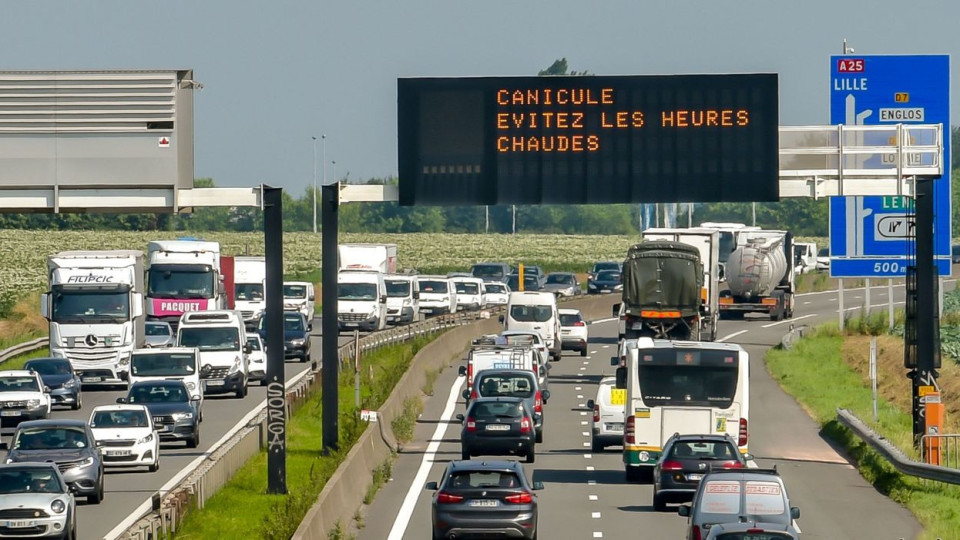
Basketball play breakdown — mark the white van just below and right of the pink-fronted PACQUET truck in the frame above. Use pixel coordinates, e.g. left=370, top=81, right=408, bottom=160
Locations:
left=177, top=309, right=249, bottom=398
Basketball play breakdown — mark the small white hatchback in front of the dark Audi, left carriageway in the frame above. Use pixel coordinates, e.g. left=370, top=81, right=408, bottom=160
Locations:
left=88, top=405, right=160, bottom=472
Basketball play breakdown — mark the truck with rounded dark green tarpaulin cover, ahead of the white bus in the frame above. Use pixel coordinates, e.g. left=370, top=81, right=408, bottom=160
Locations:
left=613, top=240, right=706, bottom=341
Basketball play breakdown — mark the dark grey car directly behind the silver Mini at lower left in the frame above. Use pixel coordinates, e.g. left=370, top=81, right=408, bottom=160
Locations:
left=0, top=419, right=104, bottom=504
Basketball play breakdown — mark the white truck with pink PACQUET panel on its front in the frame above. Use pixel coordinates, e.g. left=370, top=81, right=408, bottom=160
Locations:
left=146, top=240, right=227, bottom=331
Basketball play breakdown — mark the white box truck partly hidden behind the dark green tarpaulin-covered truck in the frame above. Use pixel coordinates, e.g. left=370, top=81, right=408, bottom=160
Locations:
left=642, top=228, right=720, bottom=341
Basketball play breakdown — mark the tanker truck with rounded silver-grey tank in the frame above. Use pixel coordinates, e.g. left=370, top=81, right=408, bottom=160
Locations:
left=720, top=230, right=795, bottom=321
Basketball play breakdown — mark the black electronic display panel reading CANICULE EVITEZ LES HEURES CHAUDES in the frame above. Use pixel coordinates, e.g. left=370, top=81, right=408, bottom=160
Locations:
left=397, top=73, right=780, bottom=206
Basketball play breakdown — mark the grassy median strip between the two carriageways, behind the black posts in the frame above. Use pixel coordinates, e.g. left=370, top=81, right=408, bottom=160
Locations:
left=174, top=335, right=436, bottom=539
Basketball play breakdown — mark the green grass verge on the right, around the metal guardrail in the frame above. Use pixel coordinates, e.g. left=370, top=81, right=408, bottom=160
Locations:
left=766, top=328, right=960, bottom=540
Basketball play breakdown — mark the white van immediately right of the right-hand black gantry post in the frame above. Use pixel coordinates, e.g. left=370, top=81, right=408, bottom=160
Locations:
left=337, top=270, right=387, bottom=332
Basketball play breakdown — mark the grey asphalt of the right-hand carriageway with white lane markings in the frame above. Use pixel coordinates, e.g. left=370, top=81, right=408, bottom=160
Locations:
left=358, top=284, right=921, bottom=540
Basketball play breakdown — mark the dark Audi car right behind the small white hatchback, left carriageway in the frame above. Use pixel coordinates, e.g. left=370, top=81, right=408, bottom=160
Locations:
left=117, top=379, right=200, bottom=448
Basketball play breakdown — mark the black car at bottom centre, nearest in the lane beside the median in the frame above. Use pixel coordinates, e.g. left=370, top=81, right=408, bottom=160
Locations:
left=425, top=461, right=543, bottom=540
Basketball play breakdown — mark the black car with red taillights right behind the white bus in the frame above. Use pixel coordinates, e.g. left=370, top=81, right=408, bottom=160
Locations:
left=653, top=434, right=749, bottom=511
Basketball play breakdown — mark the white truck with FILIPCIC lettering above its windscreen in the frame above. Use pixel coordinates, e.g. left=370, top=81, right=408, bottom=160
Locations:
left=40, top=250, right=146, bottom=385
